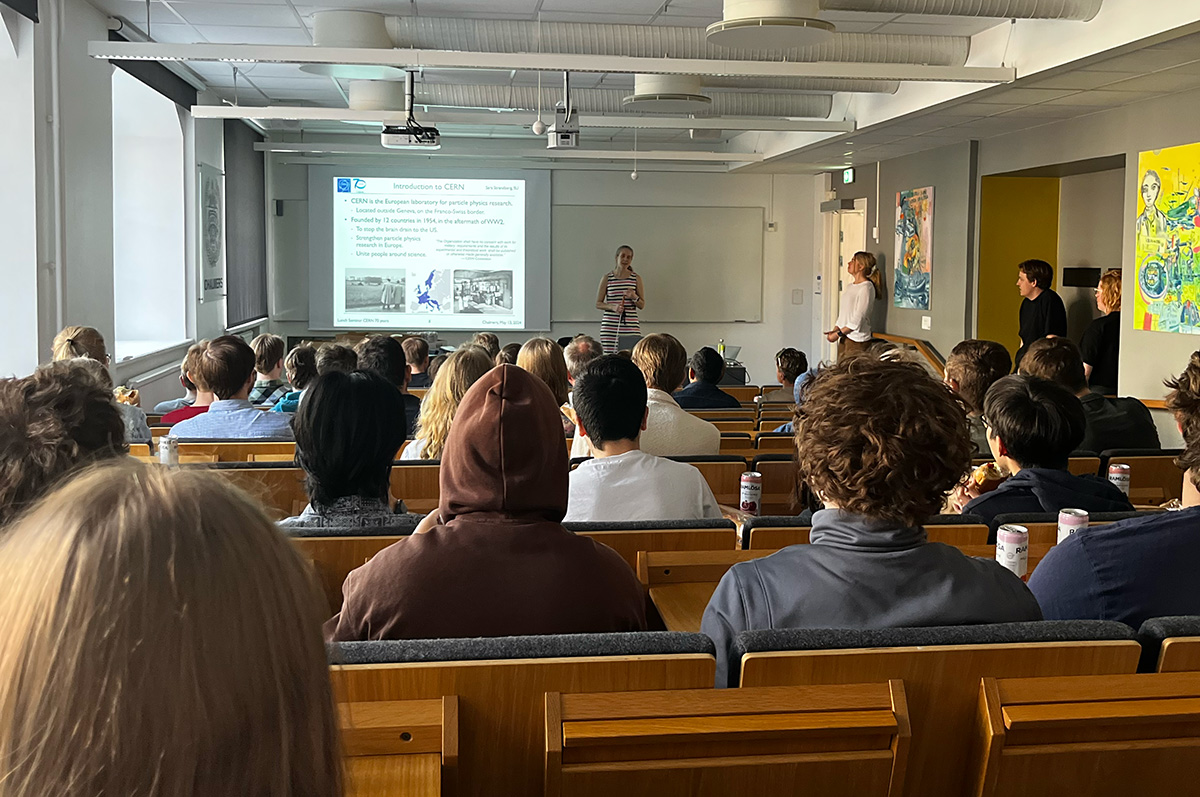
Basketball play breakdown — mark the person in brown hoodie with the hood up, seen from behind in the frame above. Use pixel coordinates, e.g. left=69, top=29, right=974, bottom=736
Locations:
left=325, top=365, right=646, bottom=642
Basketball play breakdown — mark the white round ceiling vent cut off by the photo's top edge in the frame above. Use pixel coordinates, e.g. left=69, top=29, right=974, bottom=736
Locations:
left=707, top=0, right=834, bottom=49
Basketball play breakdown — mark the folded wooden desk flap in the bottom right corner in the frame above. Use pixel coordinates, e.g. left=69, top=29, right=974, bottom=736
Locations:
left=971, top=673, right=1200, bottom=797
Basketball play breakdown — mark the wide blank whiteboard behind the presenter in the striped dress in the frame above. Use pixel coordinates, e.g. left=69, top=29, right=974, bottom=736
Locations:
left=551, top=205, right=764, bottom=322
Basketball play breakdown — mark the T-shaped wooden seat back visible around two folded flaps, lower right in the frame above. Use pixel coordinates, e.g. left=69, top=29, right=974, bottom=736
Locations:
left=742, top=641, right=1141, bottom=797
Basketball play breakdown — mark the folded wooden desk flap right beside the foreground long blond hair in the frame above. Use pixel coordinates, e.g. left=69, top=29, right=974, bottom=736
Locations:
left=337, top=695, right=458, bottom=797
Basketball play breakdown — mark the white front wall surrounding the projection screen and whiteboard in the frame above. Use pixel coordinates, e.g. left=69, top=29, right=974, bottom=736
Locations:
left=266, top=155, right=820, bottom=384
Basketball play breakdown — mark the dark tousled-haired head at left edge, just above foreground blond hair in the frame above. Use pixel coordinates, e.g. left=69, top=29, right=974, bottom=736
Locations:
left=0, top=359, right=130, bottom=526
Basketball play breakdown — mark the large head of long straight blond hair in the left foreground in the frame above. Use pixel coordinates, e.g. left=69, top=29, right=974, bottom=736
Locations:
left=0, top=462, right=342, bottom=797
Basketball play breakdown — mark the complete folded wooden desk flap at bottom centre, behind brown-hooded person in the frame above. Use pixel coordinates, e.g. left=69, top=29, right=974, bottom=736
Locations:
left=545, top=682, right=911, bottom=797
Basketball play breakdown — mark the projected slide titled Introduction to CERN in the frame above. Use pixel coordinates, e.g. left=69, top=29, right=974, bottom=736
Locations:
left=336, top=174, right=527, bottom=330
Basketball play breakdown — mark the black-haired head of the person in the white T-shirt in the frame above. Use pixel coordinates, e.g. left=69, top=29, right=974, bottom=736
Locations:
left=572, top=354, right=646, bottom=445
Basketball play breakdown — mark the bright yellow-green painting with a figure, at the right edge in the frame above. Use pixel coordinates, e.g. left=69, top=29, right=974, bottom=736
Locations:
left=1133, top=144, right=1200, bottom=335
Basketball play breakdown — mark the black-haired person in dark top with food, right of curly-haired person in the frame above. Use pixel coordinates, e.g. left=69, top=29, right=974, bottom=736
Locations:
left=962, top=374, right=1133, bottom=528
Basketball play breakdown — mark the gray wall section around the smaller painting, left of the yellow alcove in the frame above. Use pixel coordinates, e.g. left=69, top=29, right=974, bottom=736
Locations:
left=835, top=142, right=976, bottom=355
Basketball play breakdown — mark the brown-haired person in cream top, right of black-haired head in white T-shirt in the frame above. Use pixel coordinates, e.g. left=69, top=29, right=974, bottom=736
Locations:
left=571, top=334, right=721, bottom=457
